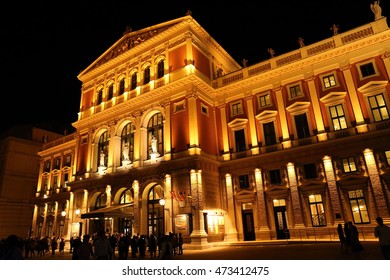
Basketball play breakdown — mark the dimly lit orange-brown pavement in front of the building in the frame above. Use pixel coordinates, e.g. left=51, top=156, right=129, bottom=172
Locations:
left=27, top=240, right=383, bottom=260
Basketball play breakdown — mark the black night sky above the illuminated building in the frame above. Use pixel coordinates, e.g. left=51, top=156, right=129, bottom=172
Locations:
left=0, top=0, right=384, bottom=131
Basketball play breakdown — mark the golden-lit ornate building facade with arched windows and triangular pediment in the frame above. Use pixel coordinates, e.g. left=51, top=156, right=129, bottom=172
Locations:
left=33, top=12, right=390, bottom=248
